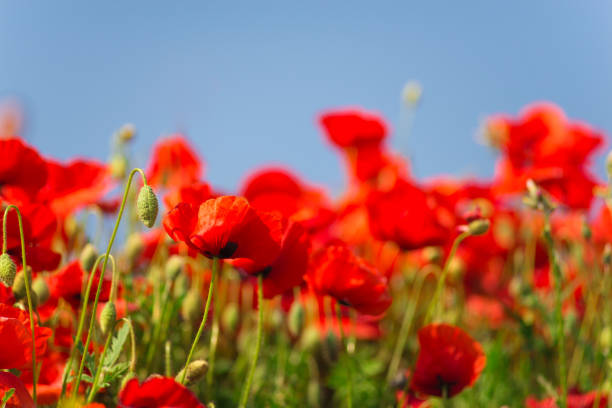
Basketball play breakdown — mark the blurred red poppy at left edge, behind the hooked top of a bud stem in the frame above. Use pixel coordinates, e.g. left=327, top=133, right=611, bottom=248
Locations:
left=0, top=204, right=61, bottom=272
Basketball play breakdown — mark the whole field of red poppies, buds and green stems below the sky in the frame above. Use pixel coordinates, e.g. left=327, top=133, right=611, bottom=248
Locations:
left=0, top=99, right=612, bottom=408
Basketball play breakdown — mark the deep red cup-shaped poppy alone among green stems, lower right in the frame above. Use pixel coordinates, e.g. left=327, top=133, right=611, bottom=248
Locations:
left=410, top=324, right=486, bottom=397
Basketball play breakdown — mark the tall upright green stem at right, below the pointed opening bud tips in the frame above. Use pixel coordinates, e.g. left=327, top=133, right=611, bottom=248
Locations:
left=544, top=212, right=567, bottom=408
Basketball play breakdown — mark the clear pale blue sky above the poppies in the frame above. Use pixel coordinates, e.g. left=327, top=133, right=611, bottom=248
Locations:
left=0, top=0, right=612, bottom=192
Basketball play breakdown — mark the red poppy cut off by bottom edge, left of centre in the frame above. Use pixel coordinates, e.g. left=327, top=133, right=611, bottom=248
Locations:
left=119, top=376, right=205, bottom=408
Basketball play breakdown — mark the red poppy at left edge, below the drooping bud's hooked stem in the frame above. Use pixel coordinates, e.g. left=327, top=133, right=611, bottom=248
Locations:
left=0, top=304, right=52, bottom=369
